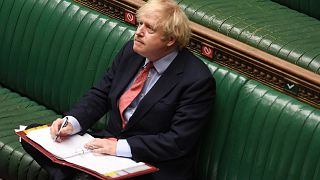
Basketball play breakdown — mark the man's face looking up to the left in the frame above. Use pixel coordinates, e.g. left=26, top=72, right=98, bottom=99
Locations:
left=133, top=14, right=175, bottom=61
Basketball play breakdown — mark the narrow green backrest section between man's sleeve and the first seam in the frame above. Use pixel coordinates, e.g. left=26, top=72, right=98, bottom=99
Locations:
left=196, top=59, right=248, bottom=180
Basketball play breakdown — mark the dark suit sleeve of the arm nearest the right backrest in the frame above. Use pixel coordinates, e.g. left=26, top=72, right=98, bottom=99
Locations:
left=127, top=72, right=215, bottom=162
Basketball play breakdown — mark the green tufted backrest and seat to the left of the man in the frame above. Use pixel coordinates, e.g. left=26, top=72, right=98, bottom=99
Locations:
left=0, top=0, right=134, bottom=179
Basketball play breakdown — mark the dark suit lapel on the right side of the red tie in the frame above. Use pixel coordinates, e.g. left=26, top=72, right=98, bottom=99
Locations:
left=124, top=53, right=184, bottom=130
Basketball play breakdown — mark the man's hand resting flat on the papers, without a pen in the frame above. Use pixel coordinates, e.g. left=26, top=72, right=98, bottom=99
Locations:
left=84, top=138, right=117, bottom=156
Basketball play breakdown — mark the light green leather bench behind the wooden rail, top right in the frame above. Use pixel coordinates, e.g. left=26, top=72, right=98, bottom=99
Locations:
left=177, top=0, right=320, bottom=74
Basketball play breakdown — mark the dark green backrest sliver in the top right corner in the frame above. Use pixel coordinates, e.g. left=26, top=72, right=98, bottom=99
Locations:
left=272, top=0, right=320, bottom=20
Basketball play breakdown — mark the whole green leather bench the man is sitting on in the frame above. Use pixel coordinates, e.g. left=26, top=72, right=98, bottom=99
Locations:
left=0, top=0, right=320, bottom=180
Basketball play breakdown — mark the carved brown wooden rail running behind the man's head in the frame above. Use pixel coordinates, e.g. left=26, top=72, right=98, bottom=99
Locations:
left=75, top=0, right=320, bottom=108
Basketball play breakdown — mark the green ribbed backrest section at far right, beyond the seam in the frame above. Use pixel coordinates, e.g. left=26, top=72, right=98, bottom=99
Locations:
left=219, top=80, right=320, bottom=180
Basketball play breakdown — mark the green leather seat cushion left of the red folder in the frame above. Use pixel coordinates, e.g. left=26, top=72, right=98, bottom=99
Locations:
left=0, top=87, right=60, bottom=179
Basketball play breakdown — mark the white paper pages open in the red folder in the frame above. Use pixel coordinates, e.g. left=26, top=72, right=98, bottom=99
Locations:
left=27, top=127, right=144, bottom=174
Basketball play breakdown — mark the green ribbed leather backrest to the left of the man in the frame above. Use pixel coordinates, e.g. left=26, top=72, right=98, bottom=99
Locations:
left=0, top=0, right=135, bottom=112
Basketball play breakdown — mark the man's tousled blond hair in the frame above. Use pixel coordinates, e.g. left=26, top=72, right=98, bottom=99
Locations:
left=137, top=0, right=191, bottom=49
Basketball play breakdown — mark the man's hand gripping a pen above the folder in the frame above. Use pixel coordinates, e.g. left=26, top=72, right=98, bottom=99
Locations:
left=50, top=118, right=73, bottom=142
